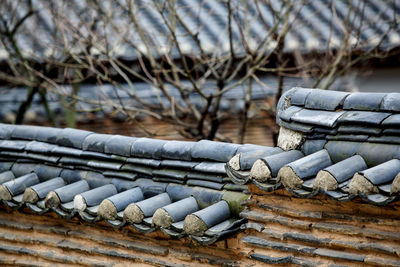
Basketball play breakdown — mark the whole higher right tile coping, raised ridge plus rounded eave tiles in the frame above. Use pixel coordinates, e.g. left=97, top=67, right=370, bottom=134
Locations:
left=226, top=88, right=400, bottom=205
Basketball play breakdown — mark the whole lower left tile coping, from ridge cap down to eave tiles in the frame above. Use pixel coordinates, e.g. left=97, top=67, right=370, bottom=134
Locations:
left=0, top=124, right=256, bottom=244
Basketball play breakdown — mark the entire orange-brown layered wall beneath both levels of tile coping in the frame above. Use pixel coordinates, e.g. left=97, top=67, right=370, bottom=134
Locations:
left=0, top=189, right=400, bottom=266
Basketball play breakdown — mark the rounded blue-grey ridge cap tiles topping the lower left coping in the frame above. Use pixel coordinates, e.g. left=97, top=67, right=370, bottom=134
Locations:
left=0, top=124, right=276, bottom=162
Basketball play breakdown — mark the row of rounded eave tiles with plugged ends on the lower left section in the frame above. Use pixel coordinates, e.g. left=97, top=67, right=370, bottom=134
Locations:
left=0, top=163, right=248, bottom=243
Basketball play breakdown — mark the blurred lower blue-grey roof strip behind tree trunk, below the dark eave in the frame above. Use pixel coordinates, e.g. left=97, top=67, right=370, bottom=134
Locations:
left=0, top=76, right=306, bottom=123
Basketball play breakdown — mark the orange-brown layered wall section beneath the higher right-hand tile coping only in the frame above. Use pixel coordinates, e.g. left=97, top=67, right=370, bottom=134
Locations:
left=240, top=185, right=400, bottom=266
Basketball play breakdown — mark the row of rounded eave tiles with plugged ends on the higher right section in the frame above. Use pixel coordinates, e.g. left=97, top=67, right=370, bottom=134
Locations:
left=226, top=140, right=400, bottom=205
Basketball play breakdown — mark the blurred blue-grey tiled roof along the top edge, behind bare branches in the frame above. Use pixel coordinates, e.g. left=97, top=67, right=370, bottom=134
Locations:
left=0, top=0, right=400, bottom=60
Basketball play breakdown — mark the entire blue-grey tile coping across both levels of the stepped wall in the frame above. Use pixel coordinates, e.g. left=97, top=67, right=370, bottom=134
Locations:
left=0, top=88, right=400, bottom=249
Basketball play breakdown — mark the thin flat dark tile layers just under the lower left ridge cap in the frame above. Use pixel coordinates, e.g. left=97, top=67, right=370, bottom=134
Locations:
left=0, top=136, right=252, bottom=195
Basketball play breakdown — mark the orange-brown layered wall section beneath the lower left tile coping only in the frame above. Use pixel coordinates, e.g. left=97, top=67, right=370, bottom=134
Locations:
left=0, top=206, right=255, bottom=266
